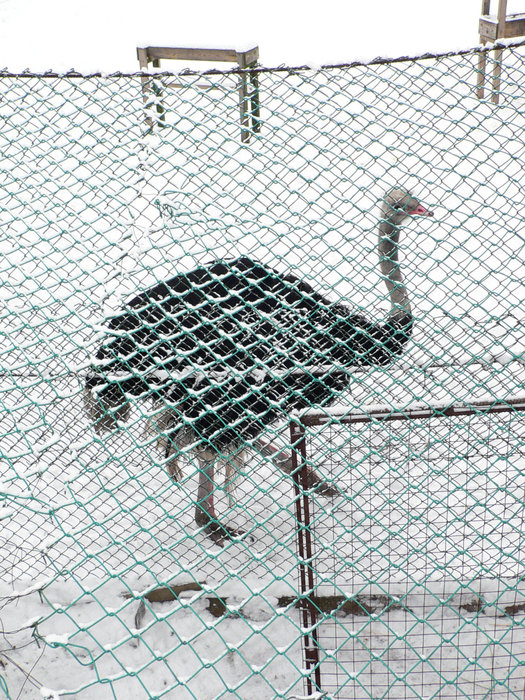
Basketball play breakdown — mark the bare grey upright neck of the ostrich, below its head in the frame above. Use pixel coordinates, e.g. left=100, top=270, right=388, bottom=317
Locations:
left=377, top=219, right=412, bottom=320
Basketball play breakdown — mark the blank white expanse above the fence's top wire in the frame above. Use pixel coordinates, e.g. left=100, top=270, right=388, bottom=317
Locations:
left=0, top=0, right=525, bottom=72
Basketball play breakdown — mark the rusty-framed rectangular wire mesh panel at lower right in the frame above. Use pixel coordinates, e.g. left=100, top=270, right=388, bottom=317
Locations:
left=292, top=399, right=525, bottom=700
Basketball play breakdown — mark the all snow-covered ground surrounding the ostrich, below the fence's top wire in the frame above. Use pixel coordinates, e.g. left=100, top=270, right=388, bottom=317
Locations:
left=0, top=46, right=525, bottom=700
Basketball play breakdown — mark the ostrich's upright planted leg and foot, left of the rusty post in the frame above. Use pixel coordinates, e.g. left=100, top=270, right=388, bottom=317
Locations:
left=195, top=450, right=245, bottom=547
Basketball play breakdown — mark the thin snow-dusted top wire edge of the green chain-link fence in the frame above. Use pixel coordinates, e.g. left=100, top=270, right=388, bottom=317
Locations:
left=0, top=39, right=525, bottom=79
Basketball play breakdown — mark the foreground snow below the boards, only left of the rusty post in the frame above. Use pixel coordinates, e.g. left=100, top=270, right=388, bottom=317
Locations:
left=2, top=578, right=302, bottom=700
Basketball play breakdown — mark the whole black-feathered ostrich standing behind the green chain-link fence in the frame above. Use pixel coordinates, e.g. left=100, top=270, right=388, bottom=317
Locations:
left=85, top=188, right=433, bottom=546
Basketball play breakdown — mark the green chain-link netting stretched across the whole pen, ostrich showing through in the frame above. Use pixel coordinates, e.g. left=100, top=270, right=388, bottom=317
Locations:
left=0, top=41, right=525, bottom=700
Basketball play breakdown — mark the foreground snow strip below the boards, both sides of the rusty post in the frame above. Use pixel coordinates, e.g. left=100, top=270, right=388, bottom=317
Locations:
left=2, top=579, right=525, bottom=700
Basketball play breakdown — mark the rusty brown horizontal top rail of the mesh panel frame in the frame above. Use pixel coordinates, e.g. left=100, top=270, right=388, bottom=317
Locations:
left=295, top=396, right=525, bottom=427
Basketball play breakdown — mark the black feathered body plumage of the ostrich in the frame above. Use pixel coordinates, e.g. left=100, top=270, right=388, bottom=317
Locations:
left=86, top=257, right=412, bottom=450
